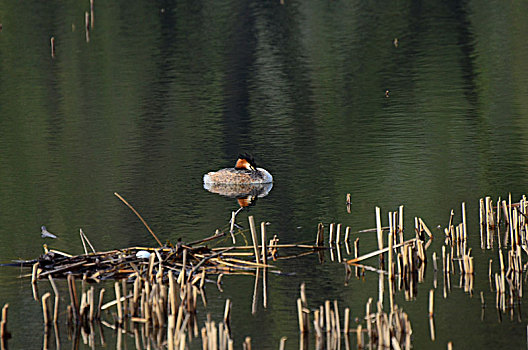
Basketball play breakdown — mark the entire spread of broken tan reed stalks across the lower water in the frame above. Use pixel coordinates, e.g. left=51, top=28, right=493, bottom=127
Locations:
left=4, top=194, right=528, bottom=350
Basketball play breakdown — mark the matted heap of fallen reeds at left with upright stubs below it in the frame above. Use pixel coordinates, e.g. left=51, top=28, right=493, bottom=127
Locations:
left=13, top=204, right=325, bottom=349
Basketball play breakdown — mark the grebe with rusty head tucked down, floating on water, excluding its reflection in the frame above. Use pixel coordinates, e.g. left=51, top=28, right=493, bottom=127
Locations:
left=204, top=154, right=273, bottom=185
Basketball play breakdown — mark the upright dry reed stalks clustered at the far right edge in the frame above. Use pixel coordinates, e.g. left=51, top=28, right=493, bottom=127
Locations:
left=442, top=194, right=528, bottom=322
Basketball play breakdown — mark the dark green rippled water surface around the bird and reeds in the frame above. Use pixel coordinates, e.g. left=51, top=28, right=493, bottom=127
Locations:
left=0, top=0, right=528, bottom=348
